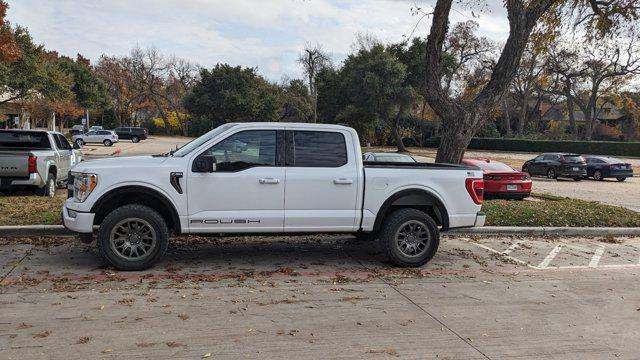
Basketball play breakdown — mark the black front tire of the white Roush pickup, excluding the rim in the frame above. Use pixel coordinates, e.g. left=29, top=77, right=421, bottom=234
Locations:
left=97, top=204, right=169, bottom=271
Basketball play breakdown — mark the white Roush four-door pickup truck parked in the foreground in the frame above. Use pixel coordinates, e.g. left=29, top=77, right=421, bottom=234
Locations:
left=62, top=123, right=485, bottom=270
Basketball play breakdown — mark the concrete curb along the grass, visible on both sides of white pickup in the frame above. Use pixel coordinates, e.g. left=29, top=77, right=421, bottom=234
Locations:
left=0, top=225, right=640, bottom=236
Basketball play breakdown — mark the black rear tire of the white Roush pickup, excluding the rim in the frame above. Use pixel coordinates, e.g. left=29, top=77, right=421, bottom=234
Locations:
left=378, top=209, right=440, bottom=267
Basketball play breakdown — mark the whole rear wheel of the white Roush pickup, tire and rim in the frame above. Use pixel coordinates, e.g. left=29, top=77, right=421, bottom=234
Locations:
left=379, top=209, right=440, bottom=267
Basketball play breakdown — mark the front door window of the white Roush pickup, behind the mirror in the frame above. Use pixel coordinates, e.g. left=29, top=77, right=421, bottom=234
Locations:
left=205, top=130, right=276, bottom=171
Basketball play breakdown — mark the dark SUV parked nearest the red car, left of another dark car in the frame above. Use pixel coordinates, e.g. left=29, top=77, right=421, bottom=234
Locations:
left=522, top=153, right=587, bottom=181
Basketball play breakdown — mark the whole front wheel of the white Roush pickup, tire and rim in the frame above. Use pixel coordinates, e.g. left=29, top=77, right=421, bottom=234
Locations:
left=98, top=204, right=169, bottom=271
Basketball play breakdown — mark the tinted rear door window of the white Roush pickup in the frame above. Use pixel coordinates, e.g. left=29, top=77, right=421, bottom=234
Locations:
left=286, top=131, right=347, bottom=167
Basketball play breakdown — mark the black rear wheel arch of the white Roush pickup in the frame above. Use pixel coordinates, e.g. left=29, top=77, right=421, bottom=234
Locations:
left=373, top=188, right=449, bottom=231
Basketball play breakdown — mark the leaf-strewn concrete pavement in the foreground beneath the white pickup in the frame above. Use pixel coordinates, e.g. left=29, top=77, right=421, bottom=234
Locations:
left=0, top=236, right=640, bottom=359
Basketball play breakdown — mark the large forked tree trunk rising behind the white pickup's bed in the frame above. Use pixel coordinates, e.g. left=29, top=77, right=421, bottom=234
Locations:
left=424, top=0, right=639, bottom=163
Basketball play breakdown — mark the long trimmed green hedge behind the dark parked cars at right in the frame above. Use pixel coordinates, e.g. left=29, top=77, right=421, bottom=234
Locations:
left=423, top=137, right=640, bottom=156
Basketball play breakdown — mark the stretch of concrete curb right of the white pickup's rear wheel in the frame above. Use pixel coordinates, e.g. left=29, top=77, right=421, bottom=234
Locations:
left=449, top=226, right=640, bottom=236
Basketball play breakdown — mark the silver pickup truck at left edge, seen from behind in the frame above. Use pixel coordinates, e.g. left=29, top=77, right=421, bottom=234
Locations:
left=0, top=130, right=82, bottom=196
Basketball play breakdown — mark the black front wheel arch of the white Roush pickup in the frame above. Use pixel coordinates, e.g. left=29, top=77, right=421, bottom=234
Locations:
left=91, top=185, right=181, bottom=233
